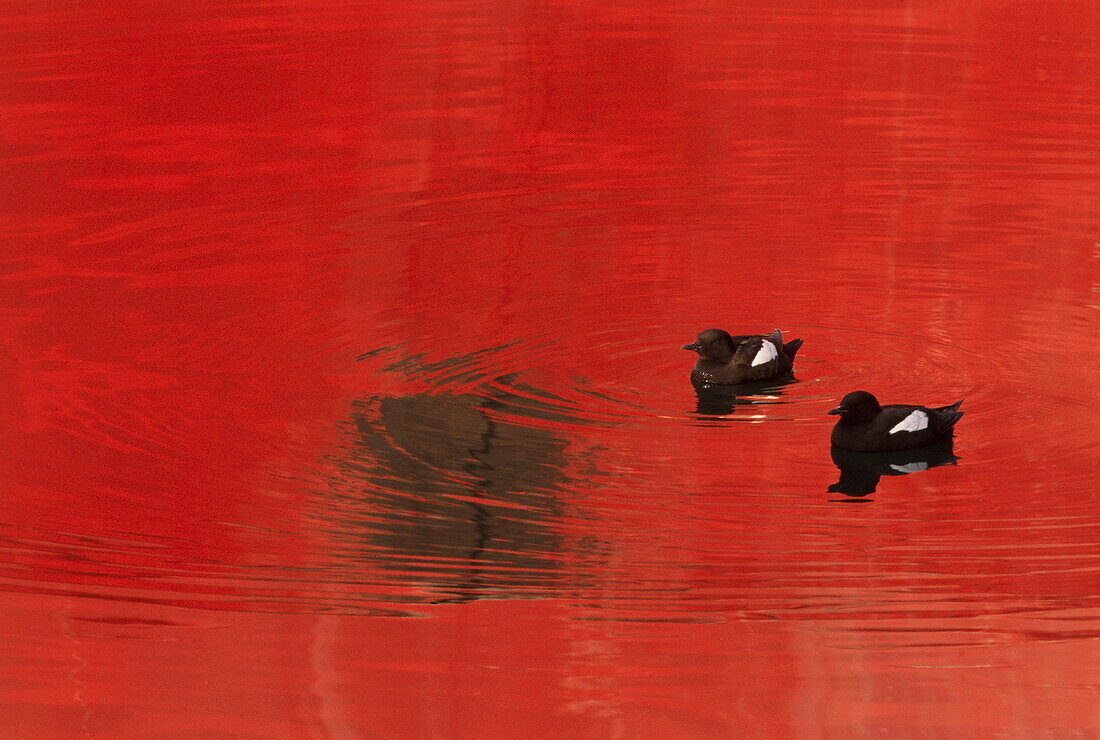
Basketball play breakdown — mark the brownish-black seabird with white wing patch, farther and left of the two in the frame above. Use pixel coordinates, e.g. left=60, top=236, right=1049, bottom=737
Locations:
left=683, top=329, right=802, bottom=386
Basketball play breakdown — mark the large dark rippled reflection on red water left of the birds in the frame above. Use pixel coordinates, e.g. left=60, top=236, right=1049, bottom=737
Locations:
left=337, top=389, right=565, bottom=601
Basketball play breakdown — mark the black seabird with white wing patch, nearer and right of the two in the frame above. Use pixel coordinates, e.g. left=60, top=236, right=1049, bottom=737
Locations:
left=828, top=390, right=963, bottom=452
